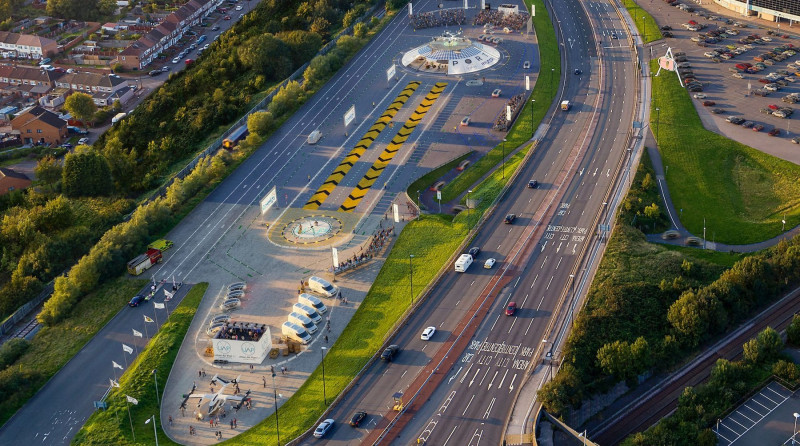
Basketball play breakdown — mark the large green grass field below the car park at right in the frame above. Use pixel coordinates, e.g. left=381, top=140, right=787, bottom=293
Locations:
left=650, top=61, right=800, bottom=244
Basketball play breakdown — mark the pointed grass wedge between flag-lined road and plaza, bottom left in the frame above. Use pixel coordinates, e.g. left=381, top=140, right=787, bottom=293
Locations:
left=72, top=282, right=208, bottom=445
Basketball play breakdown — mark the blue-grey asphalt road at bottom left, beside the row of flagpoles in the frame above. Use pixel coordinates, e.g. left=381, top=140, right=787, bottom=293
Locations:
left=0, top=283, right=191, bottom=445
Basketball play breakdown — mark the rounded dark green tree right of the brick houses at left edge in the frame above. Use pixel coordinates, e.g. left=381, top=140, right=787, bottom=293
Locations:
left=61, top=151, right=114, bottom=197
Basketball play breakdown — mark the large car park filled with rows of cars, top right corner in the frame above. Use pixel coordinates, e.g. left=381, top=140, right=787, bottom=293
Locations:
left=642, top=0, right=800, bottom=164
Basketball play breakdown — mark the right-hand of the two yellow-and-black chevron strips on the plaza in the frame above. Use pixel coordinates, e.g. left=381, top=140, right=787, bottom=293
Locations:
left=339, top=82, right=447, bottom=212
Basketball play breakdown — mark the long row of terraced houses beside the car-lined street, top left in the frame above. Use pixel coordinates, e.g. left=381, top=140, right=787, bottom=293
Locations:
left=117, top=0, right=223, bottom=70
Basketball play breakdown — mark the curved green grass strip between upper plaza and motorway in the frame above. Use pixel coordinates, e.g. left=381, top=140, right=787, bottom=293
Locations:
left=440, top=0, right=561, bottom=201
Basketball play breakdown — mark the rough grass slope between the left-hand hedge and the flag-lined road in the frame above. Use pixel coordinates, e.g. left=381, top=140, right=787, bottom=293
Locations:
left=0, top=278, right=147, bottom=424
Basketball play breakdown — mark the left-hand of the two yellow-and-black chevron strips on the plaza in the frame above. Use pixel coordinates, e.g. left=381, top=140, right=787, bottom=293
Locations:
left=303, top=81, right=421, bottom=210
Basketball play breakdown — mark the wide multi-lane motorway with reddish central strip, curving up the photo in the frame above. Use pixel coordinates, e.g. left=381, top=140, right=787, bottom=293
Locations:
left=306, top=1, right=637, bottom=445
